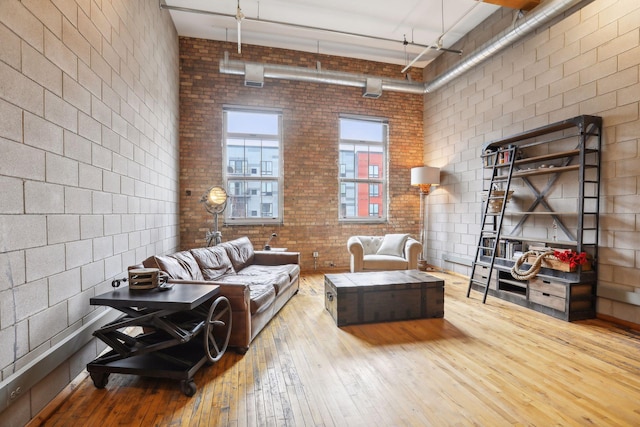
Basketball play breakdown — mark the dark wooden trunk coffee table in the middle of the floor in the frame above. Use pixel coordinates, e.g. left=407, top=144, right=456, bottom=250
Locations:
left=324, top=270, right=444, bottom=326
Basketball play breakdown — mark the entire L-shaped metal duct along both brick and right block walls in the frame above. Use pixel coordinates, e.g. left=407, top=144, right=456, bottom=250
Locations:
left=220, top=0, right=593, bottom=97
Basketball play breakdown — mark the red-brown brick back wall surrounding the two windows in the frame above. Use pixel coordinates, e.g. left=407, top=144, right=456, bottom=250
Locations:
left=180, top=38, right=424, bottom=270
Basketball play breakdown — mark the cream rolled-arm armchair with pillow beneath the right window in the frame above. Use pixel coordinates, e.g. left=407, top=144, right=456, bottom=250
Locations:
left=347, top=234, right=422, bottom=273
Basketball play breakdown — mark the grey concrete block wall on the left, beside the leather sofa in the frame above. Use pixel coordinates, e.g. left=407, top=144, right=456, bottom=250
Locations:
left=0, top=0, right=179, bottom=425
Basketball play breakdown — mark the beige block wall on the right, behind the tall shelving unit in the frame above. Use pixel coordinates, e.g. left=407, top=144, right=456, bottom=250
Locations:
left=425, top=0, right=640, bottom=324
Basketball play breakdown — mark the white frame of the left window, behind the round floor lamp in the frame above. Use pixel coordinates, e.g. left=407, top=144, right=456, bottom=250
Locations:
left=221, top=105, right=284, bottom=225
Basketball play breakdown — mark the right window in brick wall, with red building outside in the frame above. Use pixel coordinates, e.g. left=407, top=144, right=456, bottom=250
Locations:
left=338, top=116, right=388, bottom=222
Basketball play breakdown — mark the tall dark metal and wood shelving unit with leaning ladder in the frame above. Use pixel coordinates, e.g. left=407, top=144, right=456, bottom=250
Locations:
left=467, top=116, right=602, bottom=321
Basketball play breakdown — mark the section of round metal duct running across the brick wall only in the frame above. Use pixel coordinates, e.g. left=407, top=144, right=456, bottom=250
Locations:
left=220, top=53, right=424, bottom=94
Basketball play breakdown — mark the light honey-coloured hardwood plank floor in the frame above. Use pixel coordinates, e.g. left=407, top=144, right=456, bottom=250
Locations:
left=32, top=273, right=640, bottom=426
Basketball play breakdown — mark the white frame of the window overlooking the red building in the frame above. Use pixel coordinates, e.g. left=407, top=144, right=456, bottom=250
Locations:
left=337, top=114, right=389, bottom=224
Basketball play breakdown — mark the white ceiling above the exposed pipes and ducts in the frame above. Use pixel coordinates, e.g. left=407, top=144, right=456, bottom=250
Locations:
left=160, top=0, right=499, bottom=68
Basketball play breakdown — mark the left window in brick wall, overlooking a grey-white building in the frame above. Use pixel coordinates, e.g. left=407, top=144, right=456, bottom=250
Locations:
left=223, top=107, right=283, bottom=224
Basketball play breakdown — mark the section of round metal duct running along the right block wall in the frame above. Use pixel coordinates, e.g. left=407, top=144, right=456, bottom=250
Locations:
left=424, top=0, right=593, bottom=93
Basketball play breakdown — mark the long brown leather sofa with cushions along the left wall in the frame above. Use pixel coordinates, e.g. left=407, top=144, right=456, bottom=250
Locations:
left=135, top=237, right=300, bottom=354
